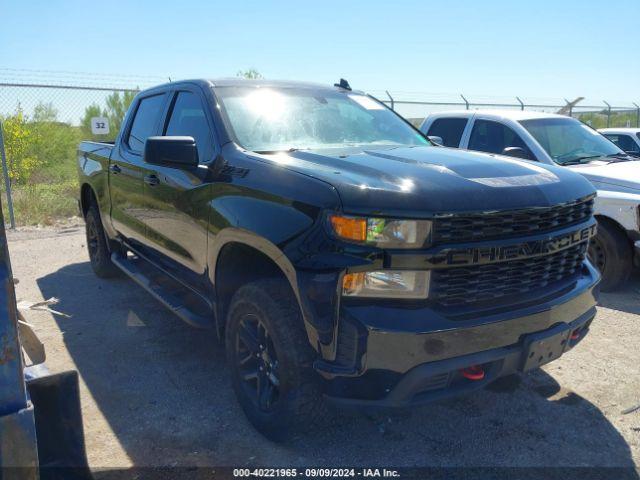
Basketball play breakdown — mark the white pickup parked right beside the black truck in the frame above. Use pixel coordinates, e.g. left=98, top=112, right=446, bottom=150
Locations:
left=420, top=110, right=640, bottom=291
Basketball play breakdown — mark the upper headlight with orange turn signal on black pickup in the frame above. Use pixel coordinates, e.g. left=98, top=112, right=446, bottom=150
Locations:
left=329, top=215, right=431, bottom=248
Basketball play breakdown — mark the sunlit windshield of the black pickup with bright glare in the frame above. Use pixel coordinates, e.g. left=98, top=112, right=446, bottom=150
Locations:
left=215, top=87, right=429, bottom=152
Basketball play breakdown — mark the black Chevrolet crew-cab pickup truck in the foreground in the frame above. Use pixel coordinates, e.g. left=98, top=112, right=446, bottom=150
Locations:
left=78, top=80, right=599, bottom=438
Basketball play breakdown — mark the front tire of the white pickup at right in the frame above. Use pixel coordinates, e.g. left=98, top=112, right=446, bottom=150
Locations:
left=588, top=220, right=633, bottom=292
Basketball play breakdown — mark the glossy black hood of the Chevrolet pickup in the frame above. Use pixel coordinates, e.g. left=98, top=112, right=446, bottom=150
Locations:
left=256, top=146, right=595, bottom=217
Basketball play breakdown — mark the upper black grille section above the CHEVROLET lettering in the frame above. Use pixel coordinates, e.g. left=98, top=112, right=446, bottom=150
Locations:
left=432, top=197, right=594, bottom=245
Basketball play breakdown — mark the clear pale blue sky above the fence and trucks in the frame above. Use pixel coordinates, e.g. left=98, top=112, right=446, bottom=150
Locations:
left=0, top=0, right=640, bottom=103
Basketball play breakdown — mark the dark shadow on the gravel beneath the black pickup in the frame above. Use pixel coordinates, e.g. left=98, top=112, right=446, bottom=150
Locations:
left=38, top=263, right=637, bottom=470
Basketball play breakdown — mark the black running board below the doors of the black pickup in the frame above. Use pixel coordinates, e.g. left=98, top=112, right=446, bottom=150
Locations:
left=111, top=253, right=213, bottom=328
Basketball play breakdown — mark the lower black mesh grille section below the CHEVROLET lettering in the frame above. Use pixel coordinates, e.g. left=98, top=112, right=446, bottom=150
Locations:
left=429, top=242, right=587, bottom=306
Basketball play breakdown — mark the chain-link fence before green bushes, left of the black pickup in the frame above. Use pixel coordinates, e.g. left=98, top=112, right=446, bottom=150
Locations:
left=0, top=82, right=144, bottom=226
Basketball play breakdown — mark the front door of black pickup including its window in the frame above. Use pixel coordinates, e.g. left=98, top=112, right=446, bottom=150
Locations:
left=144, top=86, right=217, bottom=290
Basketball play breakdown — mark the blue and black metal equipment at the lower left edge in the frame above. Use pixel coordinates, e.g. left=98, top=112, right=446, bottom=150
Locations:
left=0, top=190, right=91, bottom=480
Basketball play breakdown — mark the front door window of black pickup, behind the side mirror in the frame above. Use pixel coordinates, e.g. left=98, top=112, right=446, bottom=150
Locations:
left=165, top=92, right=213, bottom=161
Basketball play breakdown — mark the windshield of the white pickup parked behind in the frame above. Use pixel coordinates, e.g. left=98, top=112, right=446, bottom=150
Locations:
left=520, top=118, right=623, bottom=165
